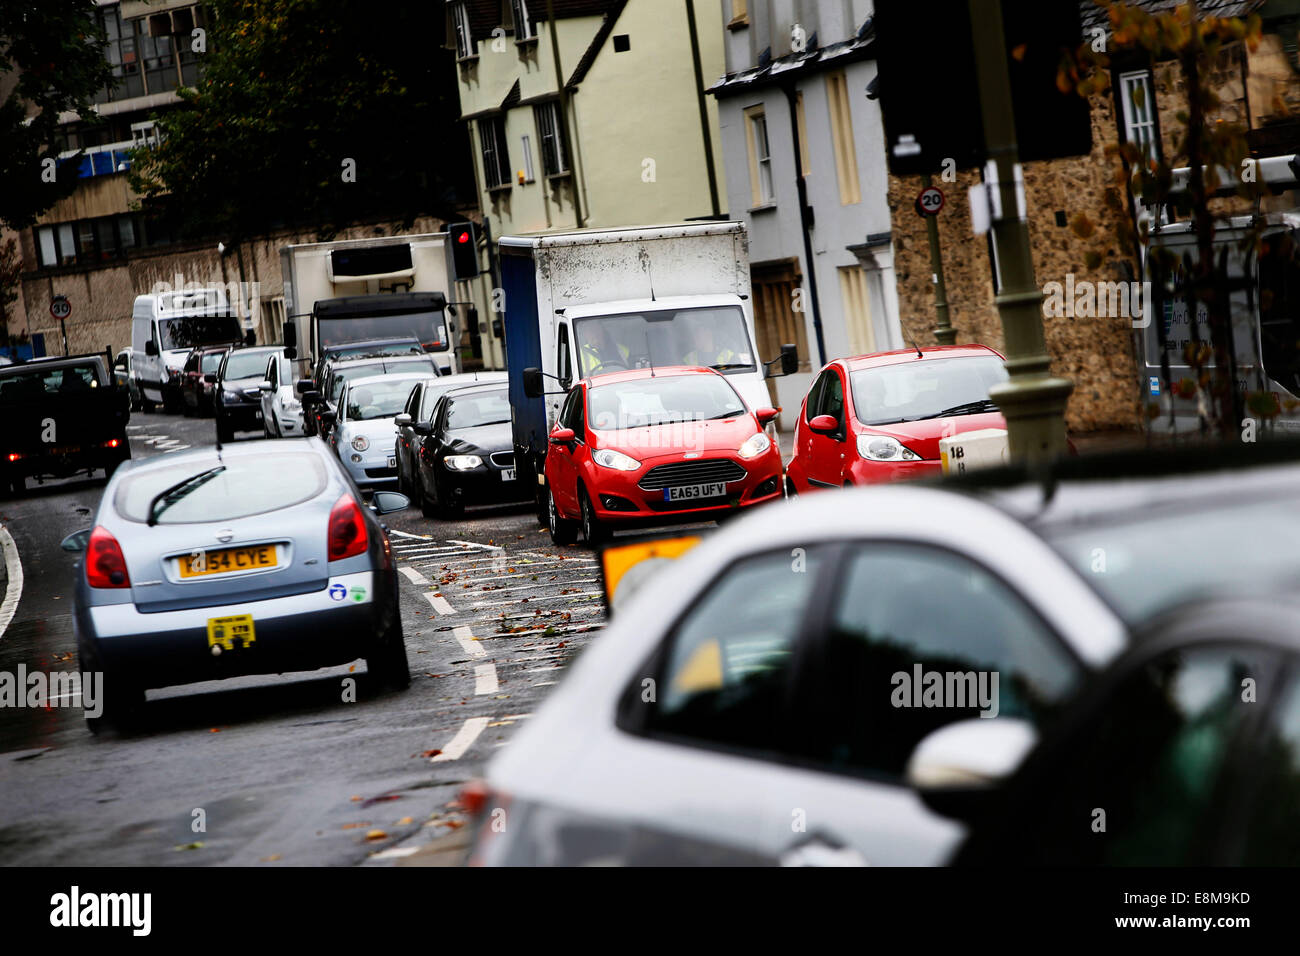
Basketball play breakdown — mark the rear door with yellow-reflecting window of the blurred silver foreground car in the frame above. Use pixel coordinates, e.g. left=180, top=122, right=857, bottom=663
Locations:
left=564, top=546, right=831, bottom=866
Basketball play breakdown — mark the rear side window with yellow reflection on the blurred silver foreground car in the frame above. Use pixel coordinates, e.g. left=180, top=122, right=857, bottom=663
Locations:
left=629, top=549, right=823, bottom=754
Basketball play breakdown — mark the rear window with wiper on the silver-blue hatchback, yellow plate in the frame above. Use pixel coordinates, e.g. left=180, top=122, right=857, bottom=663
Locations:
left=113, top=451, right=326, bottom=524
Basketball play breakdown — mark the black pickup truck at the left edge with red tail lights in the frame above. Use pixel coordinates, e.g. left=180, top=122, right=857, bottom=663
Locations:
left=0, top=352, right=131, bottom=496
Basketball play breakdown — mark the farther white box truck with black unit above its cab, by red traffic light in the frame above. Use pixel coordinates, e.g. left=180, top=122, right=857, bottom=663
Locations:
left=280, top=233, right=460, bottom=375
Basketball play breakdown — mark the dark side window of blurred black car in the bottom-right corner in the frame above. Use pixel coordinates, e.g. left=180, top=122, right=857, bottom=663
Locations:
left=963, top=644, right=1263, bottom=866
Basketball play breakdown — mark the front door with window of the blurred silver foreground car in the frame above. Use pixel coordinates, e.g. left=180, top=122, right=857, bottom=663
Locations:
left=763, top=541, right=1086, bottom=866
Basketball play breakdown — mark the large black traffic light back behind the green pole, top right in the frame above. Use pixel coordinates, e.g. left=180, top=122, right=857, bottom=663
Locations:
left=872, top=0, right=1092, bottom=176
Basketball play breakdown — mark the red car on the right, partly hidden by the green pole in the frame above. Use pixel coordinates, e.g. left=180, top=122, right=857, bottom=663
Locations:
left=787, top=345, right=1008, bottom=493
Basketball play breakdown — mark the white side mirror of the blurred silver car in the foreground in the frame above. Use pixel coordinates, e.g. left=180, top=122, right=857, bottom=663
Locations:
left=904, top=717, right=1039, bottom=821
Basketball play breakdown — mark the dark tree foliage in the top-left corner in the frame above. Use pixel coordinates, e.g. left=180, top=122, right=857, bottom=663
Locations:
left=0, top=0, right=111, bottom=229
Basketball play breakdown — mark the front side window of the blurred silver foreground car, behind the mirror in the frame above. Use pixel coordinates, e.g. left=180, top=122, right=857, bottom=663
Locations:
left=803, top=542, right=1080, bottom=779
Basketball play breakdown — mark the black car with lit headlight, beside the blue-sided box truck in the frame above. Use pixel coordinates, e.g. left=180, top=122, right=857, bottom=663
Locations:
left=408, top=384, right=532, bottom=519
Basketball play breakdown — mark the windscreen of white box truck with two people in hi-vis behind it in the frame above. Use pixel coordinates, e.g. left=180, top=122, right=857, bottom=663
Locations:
left=573, top=306, right=757, bottom=377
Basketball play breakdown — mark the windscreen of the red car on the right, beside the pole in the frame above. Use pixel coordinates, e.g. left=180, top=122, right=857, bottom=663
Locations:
left=849, top=355, right=1008, bottom=425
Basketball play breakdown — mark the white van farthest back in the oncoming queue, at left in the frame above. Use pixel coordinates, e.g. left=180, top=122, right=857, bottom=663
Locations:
left=131, top=287, right=244, bottom=411
